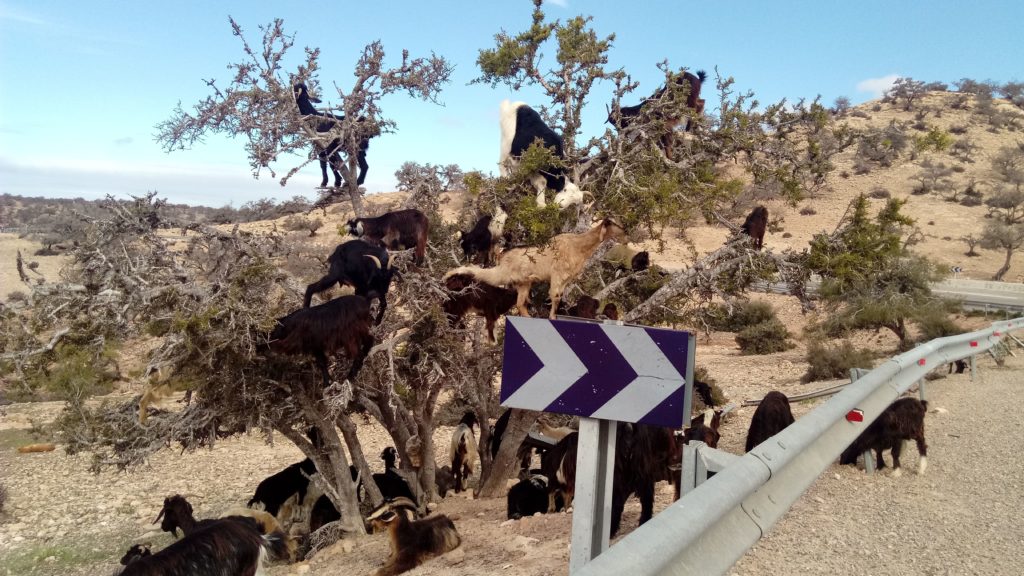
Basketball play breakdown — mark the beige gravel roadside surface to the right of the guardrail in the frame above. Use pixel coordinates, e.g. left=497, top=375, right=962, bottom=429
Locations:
left=731, top=352, right=1024, bottom=576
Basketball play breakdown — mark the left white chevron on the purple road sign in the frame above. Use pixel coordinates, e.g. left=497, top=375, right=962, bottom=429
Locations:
left=505, top=316, right=585, bottom=407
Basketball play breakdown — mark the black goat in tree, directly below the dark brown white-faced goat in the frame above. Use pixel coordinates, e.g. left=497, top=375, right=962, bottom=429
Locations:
left=302, top=240, right=394, bottom=325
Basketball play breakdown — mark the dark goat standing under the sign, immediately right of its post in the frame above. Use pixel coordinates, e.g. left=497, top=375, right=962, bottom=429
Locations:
left=611, top=422, right=682, bottom=536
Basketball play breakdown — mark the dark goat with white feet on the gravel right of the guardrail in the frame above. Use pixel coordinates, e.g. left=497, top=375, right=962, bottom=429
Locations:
left=839, top=398, right=928, bottom=477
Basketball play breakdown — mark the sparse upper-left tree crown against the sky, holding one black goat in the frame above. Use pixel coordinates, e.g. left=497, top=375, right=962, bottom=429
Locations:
left=157, top=18, right=452, bottom=214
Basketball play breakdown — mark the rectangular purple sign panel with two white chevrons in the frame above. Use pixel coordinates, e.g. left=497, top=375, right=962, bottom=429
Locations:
left=501, top=316, right=694, bottom=428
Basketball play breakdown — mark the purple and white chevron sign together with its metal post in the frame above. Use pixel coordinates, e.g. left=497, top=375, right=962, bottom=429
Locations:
left=501, top=317, right=695, bottom=573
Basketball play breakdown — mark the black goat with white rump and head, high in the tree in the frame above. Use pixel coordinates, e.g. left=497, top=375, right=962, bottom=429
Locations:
left=498, top=100, right=584, bottom=208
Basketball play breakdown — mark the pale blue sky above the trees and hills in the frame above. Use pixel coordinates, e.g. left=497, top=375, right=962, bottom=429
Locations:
left=0, top=0, right=1024, bottom=206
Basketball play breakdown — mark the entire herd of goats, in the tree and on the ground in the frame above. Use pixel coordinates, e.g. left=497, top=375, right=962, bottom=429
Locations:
left=110, top=77, right=927, bottom=576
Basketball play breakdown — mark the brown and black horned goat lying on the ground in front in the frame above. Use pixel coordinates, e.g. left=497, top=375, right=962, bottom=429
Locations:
left=367, top=498, right=462, bottom=576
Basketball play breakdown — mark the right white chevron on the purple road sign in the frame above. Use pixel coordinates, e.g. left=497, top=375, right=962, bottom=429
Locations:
left=591, top=325, right=685, bottom=422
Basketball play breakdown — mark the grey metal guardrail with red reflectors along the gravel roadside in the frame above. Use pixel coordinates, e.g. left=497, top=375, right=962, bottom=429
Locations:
left=573, top=318, right=1024, bottom=576
